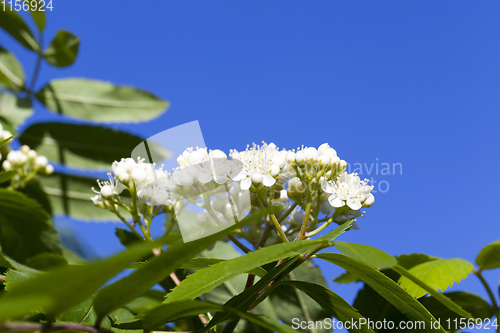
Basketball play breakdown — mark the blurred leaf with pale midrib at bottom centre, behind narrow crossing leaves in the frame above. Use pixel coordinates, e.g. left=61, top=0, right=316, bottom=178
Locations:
left=269, top=260, right=333, bottom=333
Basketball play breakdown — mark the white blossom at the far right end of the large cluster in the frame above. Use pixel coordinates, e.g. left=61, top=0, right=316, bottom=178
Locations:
left=321, top=172, right=373, bottom=210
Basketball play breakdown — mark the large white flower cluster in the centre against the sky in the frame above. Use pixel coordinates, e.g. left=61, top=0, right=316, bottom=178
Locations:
left=92, top=143, right=374, bottom=239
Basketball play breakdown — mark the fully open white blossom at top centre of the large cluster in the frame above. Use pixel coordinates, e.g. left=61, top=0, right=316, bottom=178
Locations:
left=230, top=143, right=286, bottom=190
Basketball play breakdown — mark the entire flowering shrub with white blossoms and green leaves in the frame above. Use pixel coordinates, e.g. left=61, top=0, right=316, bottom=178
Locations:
left=0, top=3, right=500, bottom=333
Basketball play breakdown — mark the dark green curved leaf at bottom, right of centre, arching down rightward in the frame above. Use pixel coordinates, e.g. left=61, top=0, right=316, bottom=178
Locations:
left=284, top=281, right=373, bottom=333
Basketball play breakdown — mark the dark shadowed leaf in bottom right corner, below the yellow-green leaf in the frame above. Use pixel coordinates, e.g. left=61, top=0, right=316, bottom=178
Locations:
left=420, top=291, right=494, bottom=322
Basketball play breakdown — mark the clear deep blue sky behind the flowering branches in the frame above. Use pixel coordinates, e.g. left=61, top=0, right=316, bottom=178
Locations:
left=0, top=0, right=500, bottom=328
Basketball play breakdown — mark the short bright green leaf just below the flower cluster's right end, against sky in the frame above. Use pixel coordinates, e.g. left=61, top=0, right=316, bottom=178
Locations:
left=334, top=241, right=398, bottom=269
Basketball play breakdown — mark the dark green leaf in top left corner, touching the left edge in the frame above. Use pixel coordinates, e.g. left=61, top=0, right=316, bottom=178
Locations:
left=0, top=3, right=39, bottom=51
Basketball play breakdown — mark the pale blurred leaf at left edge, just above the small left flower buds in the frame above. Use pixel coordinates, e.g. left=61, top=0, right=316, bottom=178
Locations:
left=0, top=92, right=33, bottom=129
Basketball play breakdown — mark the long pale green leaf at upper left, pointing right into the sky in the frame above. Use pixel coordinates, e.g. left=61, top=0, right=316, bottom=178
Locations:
left=36, top=79, right=168, bottom=122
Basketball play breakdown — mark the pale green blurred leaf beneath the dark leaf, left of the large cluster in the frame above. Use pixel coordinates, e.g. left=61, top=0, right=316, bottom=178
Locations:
left=39, top=173, right=119, bottom=222
